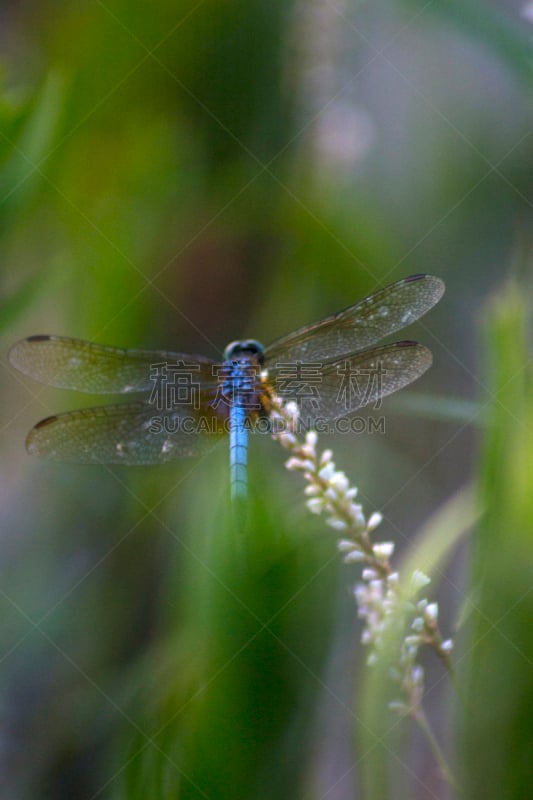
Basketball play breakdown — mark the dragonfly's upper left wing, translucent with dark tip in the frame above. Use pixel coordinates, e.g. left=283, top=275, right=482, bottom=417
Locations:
left=9, top=336, right=216, bottom=394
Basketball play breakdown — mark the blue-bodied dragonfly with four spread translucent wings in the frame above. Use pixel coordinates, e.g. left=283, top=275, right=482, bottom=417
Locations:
left=9, top=275, right=444, bottom=500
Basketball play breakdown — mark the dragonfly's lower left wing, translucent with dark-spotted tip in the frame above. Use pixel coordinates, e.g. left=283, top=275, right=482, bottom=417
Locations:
left=26, top=403, right=222, bottom=465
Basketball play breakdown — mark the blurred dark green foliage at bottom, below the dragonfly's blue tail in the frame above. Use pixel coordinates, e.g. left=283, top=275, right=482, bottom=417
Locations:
left=113, top=488, right=337, bottom=798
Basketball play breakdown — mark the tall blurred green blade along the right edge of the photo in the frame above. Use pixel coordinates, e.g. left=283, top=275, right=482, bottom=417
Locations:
left=458, top=282, right=533, bottom=800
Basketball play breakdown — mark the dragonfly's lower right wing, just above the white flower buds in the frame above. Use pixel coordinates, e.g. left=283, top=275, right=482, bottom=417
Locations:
left=269, top=341, right=433, bottom=424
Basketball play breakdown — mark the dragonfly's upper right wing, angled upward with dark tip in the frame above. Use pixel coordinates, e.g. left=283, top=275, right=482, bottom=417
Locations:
left=265, top=275, right=444, bottom=369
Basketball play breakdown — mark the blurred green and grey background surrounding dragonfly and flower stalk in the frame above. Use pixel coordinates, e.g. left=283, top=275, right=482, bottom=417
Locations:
left=0, top=0, right=533, bottom=800
